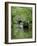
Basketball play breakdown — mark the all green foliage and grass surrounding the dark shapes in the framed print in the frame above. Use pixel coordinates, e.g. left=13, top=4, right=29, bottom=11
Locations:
left=11, top=7, right=32, bottom=39
